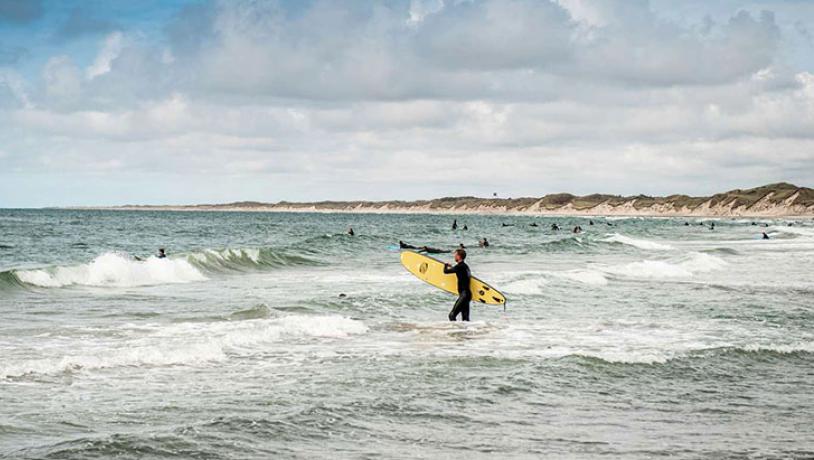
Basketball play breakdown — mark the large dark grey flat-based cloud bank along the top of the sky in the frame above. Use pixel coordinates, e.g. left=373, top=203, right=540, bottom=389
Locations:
left=159, top=0, right=792, bottom=100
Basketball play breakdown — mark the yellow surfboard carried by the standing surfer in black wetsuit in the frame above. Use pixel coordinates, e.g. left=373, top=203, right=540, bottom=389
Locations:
left=401, top=251, right=506, bottom=307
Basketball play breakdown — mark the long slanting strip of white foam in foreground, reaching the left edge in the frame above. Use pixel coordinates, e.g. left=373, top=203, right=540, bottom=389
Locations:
left=0, top=315, right=368, bottom=378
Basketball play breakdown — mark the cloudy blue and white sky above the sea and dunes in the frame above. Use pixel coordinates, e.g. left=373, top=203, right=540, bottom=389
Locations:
left=0, top=0, right=814, bottom=207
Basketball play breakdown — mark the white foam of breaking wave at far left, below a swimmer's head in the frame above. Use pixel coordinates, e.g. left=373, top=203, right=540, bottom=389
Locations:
left=15, top=252, right=207, bottom=287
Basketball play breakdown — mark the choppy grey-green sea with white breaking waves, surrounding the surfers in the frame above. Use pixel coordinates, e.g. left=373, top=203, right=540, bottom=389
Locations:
left=0, top=210, right=814, bottom=459
